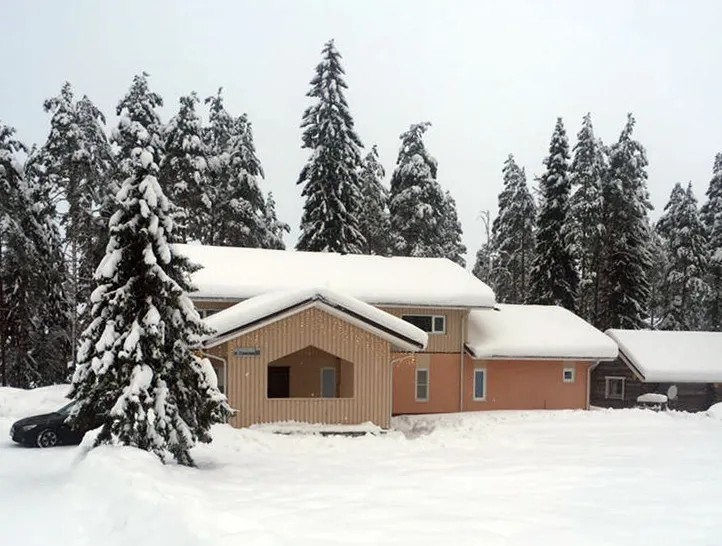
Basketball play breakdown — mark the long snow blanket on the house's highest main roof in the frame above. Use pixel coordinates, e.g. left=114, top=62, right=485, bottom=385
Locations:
left=175, top=245, right=494, bottom=307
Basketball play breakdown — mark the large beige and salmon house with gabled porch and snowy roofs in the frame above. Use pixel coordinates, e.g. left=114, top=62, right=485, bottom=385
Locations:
left=179, top=245, right=616, bottom=427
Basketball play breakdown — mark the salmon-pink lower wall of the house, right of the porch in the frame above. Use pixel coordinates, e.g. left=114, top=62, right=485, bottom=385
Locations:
left=392, top=354, right=591, bottom=414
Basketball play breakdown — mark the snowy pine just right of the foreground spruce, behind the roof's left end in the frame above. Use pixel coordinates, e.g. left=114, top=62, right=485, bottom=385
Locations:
left=158, top=92, right=210, bottom=242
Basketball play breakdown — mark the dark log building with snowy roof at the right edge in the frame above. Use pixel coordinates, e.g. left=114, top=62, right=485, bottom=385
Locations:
left=591, top=330, right=722, bottom=411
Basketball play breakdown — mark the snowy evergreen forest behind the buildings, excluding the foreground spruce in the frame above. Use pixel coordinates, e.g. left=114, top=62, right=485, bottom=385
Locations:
left=0, top=41, right=722, bottom=392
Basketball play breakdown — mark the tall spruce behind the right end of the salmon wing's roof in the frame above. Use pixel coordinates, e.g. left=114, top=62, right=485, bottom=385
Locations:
left=598, top=114, right=652, bottom=330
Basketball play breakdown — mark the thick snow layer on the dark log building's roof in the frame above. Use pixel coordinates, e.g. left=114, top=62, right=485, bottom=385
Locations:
left=606, top=330, right=722, bottom=383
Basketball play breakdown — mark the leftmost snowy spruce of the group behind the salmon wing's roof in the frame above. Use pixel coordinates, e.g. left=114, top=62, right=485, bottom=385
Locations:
left=491, top=154, right=536, bottom=303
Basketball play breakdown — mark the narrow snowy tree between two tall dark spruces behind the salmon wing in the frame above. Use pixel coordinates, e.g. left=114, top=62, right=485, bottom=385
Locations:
left=569, top=114, right=605, bottom=324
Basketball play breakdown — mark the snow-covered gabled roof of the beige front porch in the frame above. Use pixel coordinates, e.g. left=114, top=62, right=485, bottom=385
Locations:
left=204, top=288, right=428, bottom=351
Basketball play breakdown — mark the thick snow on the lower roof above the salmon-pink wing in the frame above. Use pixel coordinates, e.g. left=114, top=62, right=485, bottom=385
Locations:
left=466, top=304, right=617, bottom=360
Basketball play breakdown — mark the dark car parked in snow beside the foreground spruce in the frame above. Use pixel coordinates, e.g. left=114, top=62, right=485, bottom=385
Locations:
left=10, top=402, right=97, bottom=447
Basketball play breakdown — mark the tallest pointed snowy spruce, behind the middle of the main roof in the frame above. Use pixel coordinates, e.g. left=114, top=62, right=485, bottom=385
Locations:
left=296, top=40, right=367, bottom=254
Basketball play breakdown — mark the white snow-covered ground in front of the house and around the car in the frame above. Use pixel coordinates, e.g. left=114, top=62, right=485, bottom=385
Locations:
left=0, top=388, right=722, bottom=546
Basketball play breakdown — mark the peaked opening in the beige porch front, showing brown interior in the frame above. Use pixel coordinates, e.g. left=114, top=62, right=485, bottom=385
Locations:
left=266, top=346, right=354, bottom=398
